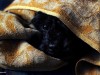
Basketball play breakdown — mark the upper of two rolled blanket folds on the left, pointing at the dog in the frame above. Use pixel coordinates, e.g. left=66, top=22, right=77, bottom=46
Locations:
left=0, top=11, right=39, bottom=39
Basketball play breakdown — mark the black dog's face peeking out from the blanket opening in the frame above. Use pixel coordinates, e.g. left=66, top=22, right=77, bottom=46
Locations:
left=29, top=12, right=92, bottom=62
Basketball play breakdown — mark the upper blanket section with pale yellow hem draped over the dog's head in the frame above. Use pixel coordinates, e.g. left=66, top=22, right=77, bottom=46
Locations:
left=5, top=0, right=100, bottom=51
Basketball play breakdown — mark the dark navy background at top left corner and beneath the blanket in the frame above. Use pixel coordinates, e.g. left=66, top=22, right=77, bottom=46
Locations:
left=0, top=0, right=75, bottom=75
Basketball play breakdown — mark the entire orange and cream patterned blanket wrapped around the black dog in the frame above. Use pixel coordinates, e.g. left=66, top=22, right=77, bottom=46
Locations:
left=0, top=0, right=100, bottom=75
